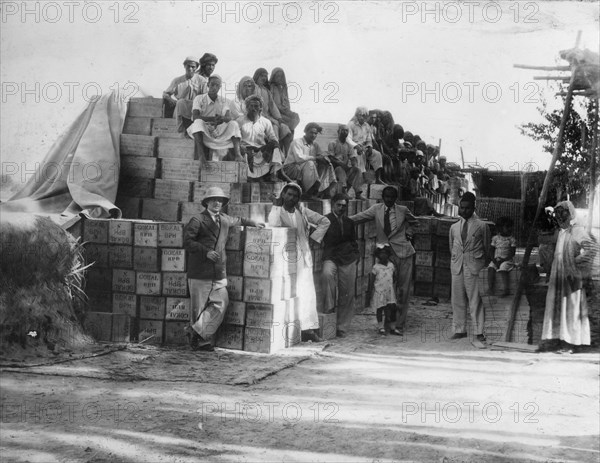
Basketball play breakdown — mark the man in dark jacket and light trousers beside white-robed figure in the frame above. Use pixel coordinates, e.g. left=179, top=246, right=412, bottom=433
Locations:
left=323, top=193, right=359, bottom=338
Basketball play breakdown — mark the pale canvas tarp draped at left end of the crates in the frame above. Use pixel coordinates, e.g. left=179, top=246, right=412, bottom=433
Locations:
left=0, top=91, right=127, bottom=221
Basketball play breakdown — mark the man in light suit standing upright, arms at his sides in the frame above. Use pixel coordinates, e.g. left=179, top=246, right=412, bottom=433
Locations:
left=450, top=192, right=490, bottom=342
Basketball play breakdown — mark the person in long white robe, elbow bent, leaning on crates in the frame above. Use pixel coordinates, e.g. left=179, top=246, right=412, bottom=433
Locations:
left=268, top=183, right=330, bottom=342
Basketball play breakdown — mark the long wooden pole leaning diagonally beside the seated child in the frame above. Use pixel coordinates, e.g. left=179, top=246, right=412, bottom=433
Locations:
left=504, top=68, right=579, bottom=341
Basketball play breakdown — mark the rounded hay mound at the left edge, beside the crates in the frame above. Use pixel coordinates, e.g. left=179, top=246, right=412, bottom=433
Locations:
left=0, top=214, right=91, bottom=353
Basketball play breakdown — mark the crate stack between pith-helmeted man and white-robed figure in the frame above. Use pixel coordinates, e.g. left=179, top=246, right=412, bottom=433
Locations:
left=217, top=227, right=300, bottom=354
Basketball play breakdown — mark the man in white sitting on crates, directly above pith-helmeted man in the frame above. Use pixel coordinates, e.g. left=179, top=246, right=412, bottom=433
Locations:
left=187, top=74, right=245, bottom=162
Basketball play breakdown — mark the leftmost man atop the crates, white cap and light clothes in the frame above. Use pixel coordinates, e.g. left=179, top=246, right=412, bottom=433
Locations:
left=163, top=56, right=208, bottom=133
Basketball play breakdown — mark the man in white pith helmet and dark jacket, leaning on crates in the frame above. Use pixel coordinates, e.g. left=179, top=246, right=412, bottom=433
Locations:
left=183, top=187, right=265, bottom=351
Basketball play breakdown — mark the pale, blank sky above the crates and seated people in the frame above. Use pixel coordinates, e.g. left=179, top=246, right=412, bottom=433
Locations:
left=0, top=1, right=600, bottom=180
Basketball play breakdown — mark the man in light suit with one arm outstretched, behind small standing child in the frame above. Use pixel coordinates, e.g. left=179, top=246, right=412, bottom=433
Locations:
left=349, top=186, right=417, bottom=336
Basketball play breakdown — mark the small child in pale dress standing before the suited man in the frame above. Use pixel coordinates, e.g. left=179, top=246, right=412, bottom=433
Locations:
left=368, top=246, right=402, bottom=336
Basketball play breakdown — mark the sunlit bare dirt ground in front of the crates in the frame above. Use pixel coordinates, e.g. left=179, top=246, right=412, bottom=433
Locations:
left=0, top=298, right=600, bottom=463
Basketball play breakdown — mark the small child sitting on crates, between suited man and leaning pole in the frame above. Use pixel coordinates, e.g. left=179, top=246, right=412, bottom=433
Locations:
left=488, top=217, right=517, bottom=296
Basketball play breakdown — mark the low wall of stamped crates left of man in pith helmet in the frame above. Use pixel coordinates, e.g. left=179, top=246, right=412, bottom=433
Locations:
left=83, top=219, right=190, bottom=344
